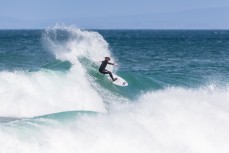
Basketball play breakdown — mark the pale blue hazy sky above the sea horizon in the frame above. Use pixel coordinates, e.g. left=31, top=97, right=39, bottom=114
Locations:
left=0, top=0, right=229, bottom=29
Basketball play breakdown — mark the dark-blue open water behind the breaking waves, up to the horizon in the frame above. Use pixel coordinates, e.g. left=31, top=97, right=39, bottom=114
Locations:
left=0, top=30, right=229, bottom=89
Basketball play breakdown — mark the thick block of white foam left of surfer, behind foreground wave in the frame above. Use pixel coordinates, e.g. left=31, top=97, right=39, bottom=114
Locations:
left=0, top=70, right=105, bottom=117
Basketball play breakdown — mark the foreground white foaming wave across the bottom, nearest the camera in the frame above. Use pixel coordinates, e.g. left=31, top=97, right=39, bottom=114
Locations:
left=0, top=85, right=229, bottom=153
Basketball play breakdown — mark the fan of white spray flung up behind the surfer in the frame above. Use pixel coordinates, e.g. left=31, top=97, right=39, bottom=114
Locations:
left=43, top=25, right=111, bottom=64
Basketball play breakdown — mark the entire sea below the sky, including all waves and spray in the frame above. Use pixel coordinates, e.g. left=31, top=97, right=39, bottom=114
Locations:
left=0, top=25, right=229, bottom=153
